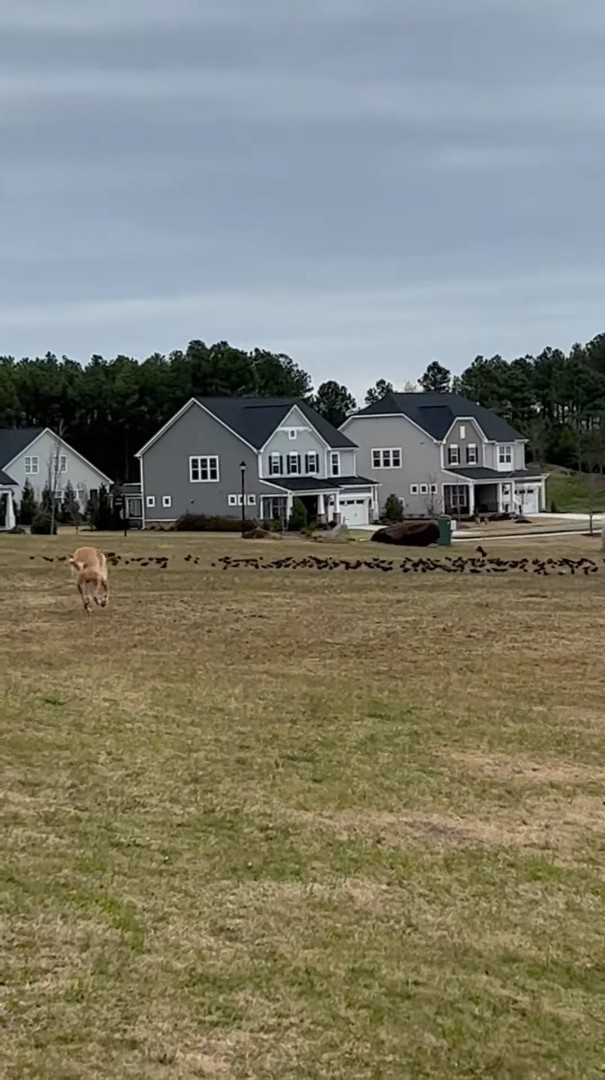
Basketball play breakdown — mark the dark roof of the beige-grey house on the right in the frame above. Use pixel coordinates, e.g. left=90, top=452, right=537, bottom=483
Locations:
left=351, top=392, right=523, bottom=443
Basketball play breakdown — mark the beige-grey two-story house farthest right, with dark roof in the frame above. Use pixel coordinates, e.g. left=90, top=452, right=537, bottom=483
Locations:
left=340, top=393, right=547, bottom=517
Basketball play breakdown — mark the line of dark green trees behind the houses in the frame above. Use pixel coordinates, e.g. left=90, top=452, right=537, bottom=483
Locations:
left=0, top=335, right=605, bottom=482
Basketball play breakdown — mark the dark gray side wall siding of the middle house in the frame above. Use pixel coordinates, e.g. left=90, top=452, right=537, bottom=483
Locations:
left=140, top=403, right=280, bottom=522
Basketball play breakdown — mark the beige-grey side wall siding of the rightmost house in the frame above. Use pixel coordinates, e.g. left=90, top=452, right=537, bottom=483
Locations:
left=344, top=416, right=449, bottom=514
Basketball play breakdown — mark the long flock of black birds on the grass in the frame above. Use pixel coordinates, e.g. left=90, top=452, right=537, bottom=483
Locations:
left=29, top=545, right=599, bottom=578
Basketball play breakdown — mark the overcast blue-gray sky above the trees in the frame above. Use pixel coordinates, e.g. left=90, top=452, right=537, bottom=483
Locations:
left=0, top=0, right=605, bottom=397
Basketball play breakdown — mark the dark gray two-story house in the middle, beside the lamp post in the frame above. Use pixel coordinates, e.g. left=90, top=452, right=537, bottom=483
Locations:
left=129, top=397, right=378, bottom=527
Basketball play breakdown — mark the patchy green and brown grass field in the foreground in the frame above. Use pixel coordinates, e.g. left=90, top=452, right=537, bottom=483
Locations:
left=0, top=535, right=605, bottom=1080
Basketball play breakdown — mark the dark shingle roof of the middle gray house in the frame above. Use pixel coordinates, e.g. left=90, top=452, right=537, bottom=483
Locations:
left=197, top=397, right=357, bottom=449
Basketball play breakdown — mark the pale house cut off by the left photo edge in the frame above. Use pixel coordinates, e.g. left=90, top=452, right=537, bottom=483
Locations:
left=0, top=428, right=111, bottom=529
